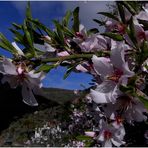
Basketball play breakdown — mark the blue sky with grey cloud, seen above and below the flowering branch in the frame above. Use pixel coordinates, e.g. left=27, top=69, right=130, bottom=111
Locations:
left=0, top=1, right=111, bottom=89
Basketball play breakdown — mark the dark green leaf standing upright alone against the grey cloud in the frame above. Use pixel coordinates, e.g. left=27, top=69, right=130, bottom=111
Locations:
left=72, top=7, right=80, bottom=32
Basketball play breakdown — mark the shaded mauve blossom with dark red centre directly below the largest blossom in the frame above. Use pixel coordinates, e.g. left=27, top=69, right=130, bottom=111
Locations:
left=103, top=95, right=147, bottom=125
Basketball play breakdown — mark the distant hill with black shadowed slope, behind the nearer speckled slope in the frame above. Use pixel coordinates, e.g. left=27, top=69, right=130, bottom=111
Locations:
left=0, top=75, right=76, bottom=132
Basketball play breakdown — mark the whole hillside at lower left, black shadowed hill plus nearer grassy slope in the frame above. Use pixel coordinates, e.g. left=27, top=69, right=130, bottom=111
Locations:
left=0, top=78, right=81, bottom=146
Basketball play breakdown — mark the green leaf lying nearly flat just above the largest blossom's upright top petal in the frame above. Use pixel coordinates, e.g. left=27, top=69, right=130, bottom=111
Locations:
left=102, top=32, right=124, bottom=41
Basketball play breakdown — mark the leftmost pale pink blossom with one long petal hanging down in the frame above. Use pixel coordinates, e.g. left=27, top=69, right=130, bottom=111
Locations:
left=0, top=58, right=44, bottom=106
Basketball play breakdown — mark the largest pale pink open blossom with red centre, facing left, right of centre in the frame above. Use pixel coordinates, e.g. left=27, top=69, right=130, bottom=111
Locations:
left=91, top=42, right=134, bottom=103
